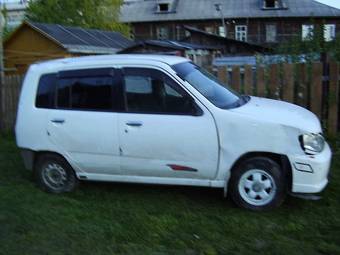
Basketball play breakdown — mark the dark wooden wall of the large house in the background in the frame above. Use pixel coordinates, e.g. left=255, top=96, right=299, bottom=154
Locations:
left=131, top=17, right=340, bottom=46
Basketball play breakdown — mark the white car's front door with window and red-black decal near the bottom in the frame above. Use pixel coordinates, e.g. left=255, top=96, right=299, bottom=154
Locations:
left=118, top=68, right=218, bottom=179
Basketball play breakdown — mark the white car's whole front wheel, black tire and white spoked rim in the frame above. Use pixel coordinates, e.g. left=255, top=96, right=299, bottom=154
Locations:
left=229, top=157, right=287, bottom=211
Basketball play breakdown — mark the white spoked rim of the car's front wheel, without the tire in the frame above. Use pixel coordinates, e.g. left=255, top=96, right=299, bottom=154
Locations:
left=238, top=169, right=276, bottom=206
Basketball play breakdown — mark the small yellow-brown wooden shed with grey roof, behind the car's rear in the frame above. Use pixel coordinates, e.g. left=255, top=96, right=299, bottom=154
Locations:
left=4, top=21, right=133, bottom=74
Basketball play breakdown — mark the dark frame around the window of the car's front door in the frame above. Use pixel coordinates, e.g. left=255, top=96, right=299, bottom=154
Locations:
left=121, top=66, right=204, bottom=117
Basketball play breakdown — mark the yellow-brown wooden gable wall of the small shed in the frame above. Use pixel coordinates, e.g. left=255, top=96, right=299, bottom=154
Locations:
left=4, top=24, right=71, bottom=75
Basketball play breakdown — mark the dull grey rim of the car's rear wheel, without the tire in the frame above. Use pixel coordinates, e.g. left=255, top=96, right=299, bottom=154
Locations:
left=42, top=163, right=67, bottom=189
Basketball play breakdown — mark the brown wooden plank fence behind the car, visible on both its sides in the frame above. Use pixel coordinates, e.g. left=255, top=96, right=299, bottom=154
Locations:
left=0, top=62, right=340, bottom=135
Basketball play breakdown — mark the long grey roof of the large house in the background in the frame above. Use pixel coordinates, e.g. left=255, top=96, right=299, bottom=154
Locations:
left=120, top=0, right=340, bottom=23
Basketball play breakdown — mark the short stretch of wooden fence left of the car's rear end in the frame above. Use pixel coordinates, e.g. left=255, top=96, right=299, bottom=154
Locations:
left=0, top=75, right=23, bottom=130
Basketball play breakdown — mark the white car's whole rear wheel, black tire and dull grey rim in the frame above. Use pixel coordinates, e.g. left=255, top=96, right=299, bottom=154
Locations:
left=34, top=154, right=79, bottom=194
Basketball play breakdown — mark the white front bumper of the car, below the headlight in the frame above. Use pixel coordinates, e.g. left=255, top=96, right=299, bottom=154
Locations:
left=288, top=143, right=332, bottom=193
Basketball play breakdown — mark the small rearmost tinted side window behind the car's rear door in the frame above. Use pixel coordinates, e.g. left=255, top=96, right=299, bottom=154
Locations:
left=35, top=74, right=57, bottom=108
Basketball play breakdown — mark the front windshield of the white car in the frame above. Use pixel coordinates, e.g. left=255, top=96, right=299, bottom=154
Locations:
left=172, top=62, right=250, bottom=109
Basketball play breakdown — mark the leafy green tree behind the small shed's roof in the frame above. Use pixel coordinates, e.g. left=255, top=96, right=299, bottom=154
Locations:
left=26, top=0, right=130, bottom=36
